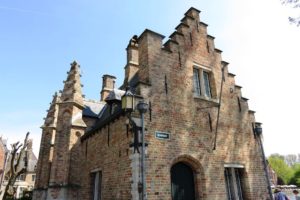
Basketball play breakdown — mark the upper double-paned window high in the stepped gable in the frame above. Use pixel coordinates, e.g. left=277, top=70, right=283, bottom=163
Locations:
left=193, top=68, right=211, bottom=98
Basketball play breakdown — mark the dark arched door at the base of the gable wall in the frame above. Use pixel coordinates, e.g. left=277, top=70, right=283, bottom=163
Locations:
left=171, top=162, right=195, bottom=200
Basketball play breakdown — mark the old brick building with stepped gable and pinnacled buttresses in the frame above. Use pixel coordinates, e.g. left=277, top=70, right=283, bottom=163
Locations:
left=34, top=8, right=268, bottom=200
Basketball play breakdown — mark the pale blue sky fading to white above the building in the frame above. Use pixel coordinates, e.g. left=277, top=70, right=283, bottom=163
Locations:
left=0, top=0, right=300, bottom=154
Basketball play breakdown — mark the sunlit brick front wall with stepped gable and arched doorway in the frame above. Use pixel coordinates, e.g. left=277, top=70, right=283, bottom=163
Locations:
left=132, top=8, right=267, bottom=200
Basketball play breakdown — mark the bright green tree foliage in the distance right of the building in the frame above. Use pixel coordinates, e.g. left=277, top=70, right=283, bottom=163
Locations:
left=268, top=154, right=300, bottom=187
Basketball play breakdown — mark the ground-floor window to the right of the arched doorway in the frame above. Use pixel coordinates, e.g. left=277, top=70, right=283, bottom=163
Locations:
left=224, top=167, right=243, bottom=200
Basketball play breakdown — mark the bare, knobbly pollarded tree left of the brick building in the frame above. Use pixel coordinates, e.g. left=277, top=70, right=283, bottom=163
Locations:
left=3, top=132, right=29, bottom=200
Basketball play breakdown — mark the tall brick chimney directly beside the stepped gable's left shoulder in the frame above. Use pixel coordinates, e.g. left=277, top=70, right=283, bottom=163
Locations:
left=124, top=35, right=139, bottom=83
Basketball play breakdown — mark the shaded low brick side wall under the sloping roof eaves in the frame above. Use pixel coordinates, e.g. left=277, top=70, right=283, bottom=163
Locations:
left=80, top=116, right=131, bottom=199
